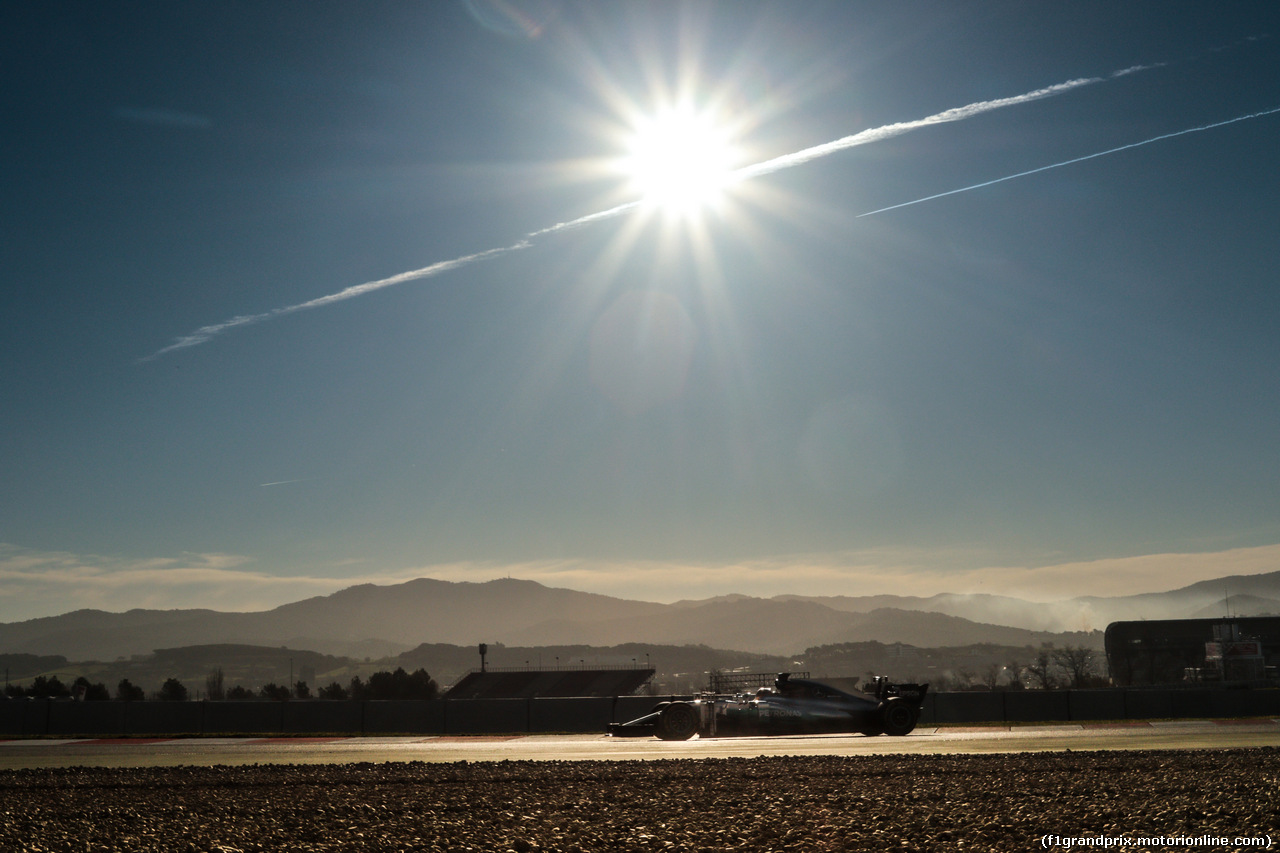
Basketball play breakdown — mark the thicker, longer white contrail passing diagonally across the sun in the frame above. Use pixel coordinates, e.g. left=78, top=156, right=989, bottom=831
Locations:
left=138, top=65, right=1155, bottom=364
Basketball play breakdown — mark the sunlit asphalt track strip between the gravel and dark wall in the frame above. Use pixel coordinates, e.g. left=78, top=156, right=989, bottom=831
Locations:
left=0, top=719, right=1280, bottom=770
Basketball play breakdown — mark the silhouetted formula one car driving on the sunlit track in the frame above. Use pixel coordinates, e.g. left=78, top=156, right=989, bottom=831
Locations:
left=609, top=672, right=929, bottom=740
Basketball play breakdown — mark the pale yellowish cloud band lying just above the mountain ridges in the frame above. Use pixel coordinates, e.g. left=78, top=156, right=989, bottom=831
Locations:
left=0, top=543, right=1280, bottom=630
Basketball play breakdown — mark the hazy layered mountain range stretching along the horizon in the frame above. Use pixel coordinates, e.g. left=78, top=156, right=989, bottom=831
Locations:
left=0, top=571, right=1280, bottom=660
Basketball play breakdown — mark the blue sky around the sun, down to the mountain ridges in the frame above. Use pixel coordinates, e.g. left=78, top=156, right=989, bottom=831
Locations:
left=0, top=0, right=1280, bottom=621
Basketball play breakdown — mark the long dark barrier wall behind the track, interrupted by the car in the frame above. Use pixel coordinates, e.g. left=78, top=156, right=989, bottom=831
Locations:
left=0, top=689, right=1280, bottom=738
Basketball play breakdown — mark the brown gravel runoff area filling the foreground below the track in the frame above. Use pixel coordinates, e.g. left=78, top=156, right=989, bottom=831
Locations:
left=0, top=747, right=1280, bottom=853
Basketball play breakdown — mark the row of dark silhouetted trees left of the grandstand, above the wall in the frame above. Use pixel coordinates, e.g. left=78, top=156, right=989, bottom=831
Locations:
left=3, top=667, right=440, bottom=702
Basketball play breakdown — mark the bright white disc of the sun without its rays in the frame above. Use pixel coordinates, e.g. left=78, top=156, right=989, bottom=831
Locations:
left=620, top=106, right=739, bottom=216
